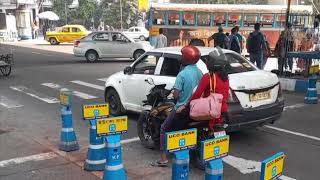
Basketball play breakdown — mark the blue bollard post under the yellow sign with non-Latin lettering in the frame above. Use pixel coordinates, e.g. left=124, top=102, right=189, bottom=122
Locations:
left=103, top=135, right=127, bottom=180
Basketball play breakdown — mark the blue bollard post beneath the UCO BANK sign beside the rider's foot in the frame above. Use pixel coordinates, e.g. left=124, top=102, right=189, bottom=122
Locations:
left=172, top=149, right=189, bottom=180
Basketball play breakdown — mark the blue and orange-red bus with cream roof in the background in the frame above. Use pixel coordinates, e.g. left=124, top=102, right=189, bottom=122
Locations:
left=148, top=3, right=314, bottom=49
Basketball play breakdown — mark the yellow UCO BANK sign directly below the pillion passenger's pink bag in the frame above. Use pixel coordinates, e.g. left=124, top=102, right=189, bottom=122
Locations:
left=201, top=136, right=229, bottom=161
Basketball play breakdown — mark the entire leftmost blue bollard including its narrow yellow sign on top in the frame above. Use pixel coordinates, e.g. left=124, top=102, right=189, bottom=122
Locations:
left=59, top=89, right=79, bottom=152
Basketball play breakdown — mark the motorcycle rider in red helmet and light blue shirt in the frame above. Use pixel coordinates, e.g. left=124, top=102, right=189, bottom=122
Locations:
left=151, top=46, right=202, bottom=167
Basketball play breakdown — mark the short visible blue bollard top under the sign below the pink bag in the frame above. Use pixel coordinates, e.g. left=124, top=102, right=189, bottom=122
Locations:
left=205, top=158, right=223, bottom=180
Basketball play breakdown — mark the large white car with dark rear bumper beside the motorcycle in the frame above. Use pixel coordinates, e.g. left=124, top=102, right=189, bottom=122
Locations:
left=105, top=47, right=284, bottom=131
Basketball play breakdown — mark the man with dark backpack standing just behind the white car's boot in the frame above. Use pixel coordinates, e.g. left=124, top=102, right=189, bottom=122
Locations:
left=247, top=23, right=266, bottom=69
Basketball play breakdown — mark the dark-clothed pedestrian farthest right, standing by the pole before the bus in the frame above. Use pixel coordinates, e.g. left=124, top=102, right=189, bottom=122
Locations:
left=275, top=23, right=294, bottom=75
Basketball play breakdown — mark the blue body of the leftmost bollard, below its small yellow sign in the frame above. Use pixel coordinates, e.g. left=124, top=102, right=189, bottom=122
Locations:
left=59, top=106, right=79, bottom=152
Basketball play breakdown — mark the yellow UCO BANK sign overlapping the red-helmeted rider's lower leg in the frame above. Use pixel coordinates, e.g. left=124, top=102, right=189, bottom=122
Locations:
left=166, top=128, right=197, bottom=152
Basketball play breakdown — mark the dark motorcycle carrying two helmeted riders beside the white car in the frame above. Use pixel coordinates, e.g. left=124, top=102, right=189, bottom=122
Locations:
left=137, top=78, right=225, bottom=169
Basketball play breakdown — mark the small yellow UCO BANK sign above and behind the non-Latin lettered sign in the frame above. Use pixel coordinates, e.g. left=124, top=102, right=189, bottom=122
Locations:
left=82, top=104, right=109, bottom=120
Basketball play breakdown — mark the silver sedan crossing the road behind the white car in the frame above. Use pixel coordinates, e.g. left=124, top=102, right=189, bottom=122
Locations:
left=73, top=31, right=152, bottom=62
